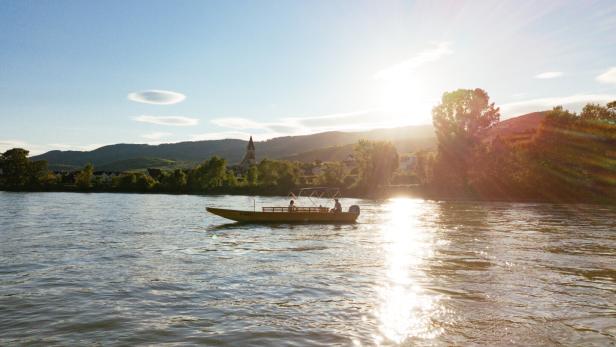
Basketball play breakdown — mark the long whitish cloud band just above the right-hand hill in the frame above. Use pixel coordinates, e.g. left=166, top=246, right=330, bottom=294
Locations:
left=500, top=94, right=616, bottom=118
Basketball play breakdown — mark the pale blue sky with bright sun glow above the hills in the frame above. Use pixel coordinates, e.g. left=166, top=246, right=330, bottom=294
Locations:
left=0, top=0, right=616, bottom=153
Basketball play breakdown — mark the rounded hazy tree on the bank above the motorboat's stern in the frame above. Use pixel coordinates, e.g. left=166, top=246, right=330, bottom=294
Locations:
left=355, top=140, right=399, bottom=193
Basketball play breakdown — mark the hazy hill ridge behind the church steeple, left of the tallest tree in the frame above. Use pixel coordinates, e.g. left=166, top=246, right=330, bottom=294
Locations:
left=31, top=125, right=434, bottom=171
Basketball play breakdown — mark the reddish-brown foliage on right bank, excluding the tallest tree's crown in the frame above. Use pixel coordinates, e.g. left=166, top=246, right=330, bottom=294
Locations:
left=418, top=99, right=616, bottom=202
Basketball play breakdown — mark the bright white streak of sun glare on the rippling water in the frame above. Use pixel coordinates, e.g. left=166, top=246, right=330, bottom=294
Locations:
left=375, top=198, right=442, bottom=344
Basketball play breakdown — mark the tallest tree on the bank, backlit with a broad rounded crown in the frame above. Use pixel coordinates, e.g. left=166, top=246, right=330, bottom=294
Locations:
left=432, top=88, right=500, bottom=188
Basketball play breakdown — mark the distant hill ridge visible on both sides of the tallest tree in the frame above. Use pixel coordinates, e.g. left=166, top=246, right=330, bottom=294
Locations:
left=32, top=112, right=545, bottom=171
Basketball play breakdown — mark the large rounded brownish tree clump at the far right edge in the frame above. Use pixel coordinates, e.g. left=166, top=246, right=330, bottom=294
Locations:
left=528, top=103, right=616, bottom=201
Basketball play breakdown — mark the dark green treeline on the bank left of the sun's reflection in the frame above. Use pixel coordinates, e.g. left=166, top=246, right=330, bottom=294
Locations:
left=0, top=141, right=398, bottom=196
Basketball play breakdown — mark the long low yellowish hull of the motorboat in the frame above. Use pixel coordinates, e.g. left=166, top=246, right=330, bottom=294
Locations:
left=206, top=207, right=359, bottom=224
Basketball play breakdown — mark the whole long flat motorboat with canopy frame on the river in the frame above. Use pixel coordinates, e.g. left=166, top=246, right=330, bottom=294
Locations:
left=206, top=188, right=359, bottom=223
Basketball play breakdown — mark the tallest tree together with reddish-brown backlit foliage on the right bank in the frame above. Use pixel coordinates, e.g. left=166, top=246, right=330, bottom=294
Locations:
left=417, top=89, right=616, bottom=203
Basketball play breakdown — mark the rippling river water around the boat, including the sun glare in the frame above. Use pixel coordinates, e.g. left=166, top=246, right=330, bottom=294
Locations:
left=0, top=192, right=616, bottom=346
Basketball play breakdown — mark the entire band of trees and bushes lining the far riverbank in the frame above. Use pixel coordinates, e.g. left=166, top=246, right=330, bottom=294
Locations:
left=0, top=89, right=616, bottom=204
